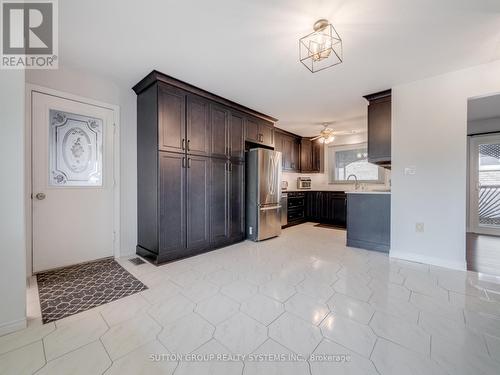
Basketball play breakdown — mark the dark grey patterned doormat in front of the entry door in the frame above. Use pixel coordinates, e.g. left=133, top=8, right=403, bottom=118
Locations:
left=36, top=258, right=147, bottom=323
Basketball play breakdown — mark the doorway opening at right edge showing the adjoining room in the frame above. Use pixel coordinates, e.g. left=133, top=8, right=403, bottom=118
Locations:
left=466, top=95, right=500, bottom=275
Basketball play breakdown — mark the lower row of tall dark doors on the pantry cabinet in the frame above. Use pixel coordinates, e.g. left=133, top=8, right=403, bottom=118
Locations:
left=137, top=152, right=245, bottom=263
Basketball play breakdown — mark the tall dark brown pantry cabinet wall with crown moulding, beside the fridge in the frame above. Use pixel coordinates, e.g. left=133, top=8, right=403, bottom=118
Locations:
left=133, top=71, right=276, bottom=263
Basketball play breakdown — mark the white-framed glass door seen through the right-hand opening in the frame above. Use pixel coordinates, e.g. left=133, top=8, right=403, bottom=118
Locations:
left=469, top=134, right=500, bottom=235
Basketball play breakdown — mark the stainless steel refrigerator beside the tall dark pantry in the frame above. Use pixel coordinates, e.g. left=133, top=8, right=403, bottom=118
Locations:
left=246, top=148, right=281, bottom=241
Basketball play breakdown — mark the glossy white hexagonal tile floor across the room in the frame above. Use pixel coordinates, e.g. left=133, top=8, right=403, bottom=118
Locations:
left=0, top=223, right=500, bottom=375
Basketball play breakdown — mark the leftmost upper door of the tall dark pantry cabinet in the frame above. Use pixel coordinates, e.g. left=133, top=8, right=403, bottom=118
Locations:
left=158, top=85, right=186, bottom=152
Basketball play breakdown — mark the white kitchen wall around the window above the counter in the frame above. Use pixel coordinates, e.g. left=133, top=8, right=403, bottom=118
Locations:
left=283, top=132, right=390, bottom=191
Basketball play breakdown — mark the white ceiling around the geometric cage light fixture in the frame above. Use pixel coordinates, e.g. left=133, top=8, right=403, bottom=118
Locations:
left=59, top=0, right=500, bottom=136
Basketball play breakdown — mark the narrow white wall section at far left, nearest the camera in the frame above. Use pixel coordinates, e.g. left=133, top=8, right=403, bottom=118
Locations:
left=0, top=70, right=26, bottom=335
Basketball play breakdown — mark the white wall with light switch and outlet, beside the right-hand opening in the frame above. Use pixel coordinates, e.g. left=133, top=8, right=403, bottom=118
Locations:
left=391, top=60, right=500, bottom=269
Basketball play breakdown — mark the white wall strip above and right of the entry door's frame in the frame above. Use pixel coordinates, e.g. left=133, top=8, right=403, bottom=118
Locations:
left=26, top=68, right=137, bottom=262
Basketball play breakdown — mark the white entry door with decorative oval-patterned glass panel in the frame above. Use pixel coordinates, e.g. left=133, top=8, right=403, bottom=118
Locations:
left=31, top=91, right=114, bottom=272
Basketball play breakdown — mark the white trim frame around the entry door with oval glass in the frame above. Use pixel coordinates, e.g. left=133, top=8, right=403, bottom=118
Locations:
left=24, top=83, right=121, bottom=277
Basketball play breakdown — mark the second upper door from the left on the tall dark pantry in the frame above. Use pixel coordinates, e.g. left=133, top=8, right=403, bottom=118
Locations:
left=185, top=95, right=211, bottom=156
